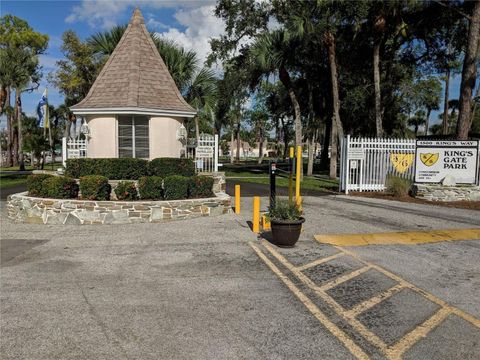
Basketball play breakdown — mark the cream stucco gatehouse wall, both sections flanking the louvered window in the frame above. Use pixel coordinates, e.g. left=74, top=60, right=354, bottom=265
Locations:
left=87, top=115, right=184, bottom=159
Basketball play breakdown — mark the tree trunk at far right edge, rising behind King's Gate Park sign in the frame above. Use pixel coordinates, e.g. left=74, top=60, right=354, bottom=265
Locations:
left=457, top=0, right=480, bottom=140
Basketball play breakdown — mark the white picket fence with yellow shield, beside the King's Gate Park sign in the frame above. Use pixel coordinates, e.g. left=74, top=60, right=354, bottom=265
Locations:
left=340, top=135, right=415, bottom=194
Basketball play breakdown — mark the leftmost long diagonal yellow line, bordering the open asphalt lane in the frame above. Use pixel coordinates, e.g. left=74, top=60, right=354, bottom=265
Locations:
left=250, top=243, right=369, bottom=359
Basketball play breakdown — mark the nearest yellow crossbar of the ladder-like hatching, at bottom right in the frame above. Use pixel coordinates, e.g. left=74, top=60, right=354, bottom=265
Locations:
left=387, top=308, right=451, bottom=359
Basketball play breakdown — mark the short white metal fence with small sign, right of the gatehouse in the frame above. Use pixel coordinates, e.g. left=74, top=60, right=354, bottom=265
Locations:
left=187, top=134, right=218, bottom=173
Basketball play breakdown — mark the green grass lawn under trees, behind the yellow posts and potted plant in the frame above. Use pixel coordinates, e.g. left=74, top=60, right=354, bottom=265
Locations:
left=225, top=171, right=338, bottom=191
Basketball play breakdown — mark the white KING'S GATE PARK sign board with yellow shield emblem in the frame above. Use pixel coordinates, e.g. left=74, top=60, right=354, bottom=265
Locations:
left=415, top=140, right=479, bottom=184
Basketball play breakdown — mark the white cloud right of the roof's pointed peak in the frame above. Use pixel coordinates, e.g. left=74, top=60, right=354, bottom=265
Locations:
left=158, top=5, right=224, bottom=67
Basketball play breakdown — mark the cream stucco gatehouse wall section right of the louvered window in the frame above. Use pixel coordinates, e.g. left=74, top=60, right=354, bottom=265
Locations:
left=150, top=117, right=183, bottom=159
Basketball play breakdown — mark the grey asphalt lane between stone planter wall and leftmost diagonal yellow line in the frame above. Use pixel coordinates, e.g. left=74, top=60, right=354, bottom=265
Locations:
left=0, top=214, right=352, bottom=359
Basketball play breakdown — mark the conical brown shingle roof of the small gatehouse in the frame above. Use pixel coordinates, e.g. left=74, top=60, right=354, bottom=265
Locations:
left=71, top=8, right=195, bottom=116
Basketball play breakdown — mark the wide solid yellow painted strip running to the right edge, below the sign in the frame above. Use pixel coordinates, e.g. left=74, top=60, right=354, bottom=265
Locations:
left=315, top=229, right=480, bottom=246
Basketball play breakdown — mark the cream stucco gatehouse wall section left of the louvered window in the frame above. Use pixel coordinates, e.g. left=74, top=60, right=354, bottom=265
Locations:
left=87, top=115, right=118, bottom=158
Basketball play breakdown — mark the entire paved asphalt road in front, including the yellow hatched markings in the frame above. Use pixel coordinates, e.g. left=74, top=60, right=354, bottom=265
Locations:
left=0, top=190, right=480, bottom=359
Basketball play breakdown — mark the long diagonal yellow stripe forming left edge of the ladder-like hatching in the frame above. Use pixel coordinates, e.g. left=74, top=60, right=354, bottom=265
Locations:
left=262, top=241, right=387, bottom=353
